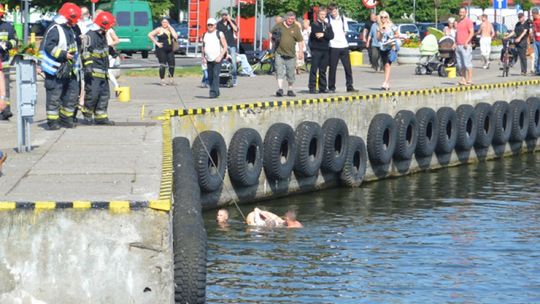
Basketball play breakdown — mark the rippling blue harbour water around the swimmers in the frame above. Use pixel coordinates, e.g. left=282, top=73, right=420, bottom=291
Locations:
left=205, top=153, right=540, bottom=303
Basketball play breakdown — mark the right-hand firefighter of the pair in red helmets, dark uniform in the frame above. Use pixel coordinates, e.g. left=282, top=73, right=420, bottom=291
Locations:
left=82, top=12, right=116, bottom=125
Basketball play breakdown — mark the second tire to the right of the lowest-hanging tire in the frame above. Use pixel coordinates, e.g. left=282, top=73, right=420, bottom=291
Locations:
left=394, top=110, right=418, bottom=160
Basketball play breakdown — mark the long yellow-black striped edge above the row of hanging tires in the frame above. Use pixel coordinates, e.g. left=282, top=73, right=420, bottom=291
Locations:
left=165, top=79, right=540, bottom=117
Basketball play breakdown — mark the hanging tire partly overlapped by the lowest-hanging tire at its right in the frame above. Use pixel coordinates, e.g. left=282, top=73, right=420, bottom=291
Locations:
left=321, top=118, right=349, bottom=173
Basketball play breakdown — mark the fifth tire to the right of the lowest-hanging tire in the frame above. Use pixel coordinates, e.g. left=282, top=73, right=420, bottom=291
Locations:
left=456, top=104, right=477, bottom=151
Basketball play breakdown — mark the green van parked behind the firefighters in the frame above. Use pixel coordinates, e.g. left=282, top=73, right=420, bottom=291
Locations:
left=112, top=0, right=154, bottom=58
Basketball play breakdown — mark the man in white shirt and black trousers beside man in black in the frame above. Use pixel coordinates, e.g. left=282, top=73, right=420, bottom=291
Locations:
left=328, top=4, right=358, bottom=93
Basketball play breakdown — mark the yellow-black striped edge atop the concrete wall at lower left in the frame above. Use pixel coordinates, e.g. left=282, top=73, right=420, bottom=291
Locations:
left=0, top=200, right=171, bottom=212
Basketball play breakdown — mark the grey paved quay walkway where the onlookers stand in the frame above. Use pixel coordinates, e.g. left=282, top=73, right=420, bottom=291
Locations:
left=0, top=56, right=531, bottom=201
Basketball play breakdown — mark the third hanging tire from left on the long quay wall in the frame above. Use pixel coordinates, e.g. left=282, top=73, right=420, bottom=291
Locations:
left=263, top=123, right=296, bottom=180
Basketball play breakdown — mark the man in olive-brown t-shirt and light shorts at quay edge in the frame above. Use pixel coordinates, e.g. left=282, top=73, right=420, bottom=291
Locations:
left=272, top=12, right=304, bottom=97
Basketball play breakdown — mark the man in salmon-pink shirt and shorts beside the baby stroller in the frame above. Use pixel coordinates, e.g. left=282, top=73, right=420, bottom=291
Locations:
left=456, top=7, right=474, bottom=85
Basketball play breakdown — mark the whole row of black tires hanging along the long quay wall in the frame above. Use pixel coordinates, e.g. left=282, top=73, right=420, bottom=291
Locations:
left=192, top=98, right=540, bottom=192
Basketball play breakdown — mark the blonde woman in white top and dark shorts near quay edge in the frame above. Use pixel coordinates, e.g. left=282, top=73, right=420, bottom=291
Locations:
left=377, top=11, right=398, bottom=91
